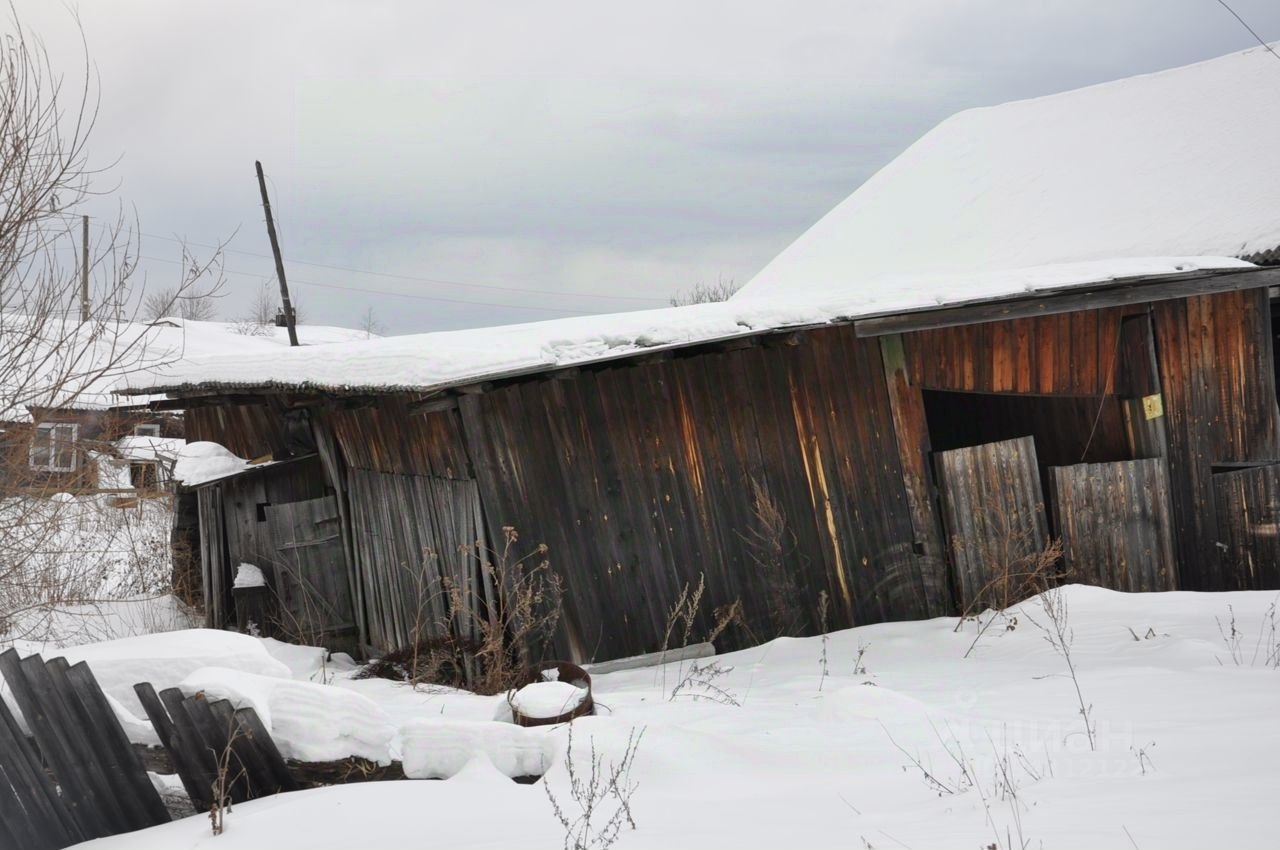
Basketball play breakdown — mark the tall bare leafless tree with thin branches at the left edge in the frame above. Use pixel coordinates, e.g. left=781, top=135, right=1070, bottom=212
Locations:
left=0, top=5, right=221, bottom=647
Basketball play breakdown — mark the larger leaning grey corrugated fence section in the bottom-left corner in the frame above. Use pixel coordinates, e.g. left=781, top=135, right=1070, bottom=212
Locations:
left=0, top=649, right=170, bottom=850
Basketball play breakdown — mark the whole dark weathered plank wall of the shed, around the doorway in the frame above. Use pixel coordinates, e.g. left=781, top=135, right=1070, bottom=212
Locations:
left=183, top=289, right=1280, bottom=658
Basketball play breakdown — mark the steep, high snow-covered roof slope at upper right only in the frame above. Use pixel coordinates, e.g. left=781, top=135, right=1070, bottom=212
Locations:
left=742, top=46, right=1280, bottom=302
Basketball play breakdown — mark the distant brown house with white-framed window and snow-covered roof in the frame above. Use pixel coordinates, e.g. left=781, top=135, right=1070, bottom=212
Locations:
left=0, top=319, right=367, bottom=493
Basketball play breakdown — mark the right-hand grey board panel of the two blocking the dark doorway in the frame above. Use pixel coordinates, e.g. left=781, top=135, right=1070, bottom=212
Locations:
left=1050, top=457, right=1178, bottom=591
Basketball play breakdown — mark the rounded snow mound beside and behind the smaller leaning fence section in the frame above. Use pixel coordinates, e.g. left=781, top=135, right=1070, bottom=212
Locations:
left=179, top=662, right=396, bottom=764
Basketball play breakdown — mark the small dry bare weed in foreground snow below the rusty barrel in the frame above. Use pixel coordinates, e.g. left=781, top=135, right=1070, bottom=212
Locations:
left=543, top=723, right=644, bottom=850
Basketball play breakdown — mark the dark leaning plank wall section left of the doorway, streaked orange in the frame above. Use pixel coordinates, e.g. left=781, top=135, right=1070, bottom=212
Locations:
left=461, top=322, right=946, bottom=658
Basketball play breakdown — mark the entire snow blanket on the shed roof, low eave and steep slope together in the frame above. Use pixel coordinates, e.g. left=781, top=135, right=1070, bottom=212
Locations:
left=122, top=49, right=1280, bottom=401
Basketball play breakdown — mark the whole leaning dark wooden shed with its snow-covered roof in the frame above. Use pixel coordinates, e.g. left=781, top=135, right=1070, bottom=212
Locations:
left=129, top=43, right=1280, bottom=659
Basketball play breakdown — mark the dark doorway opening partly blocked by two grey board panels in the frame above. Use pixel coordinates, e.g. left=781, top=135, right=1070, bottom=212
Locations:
left=922, top=315, right=1176, bottom=596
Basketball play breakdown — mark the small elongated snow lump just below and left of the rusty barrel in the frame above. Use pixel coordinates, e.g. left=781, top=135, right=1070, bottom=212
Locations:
left=401, top=717, right=556, bottom=780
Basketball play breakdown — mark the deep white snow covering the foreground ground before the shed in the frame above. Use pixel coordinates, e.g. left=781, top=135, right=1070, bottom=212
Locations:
left=72, top=586, right=1280, bottom=850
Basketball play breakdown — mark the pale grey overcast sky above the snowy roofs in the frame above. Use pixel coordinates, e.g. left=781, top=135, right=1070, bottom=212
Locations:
left=17, top=0, right=1280, bottom=333
